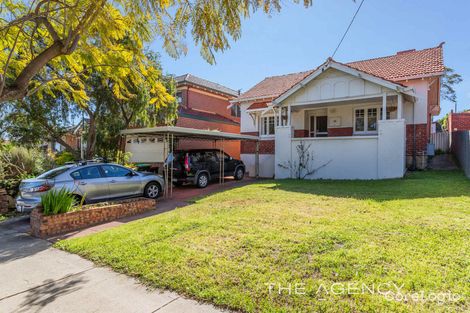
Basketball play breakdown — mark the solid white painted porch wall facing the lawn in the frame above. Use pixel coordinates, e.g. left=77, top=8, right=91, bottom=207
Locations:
left=274, top=120, right=405, bottom=179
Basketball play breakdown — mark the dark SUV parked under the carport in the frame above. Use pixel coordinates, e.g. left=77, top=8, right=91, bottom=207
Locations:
left=173, top=149, right=245, bottom=188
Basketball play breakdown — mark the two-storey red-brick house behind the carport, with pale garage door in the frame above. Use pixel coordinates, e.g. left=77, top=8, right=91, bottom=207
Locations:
left=126, top=74, right=240, bottom=163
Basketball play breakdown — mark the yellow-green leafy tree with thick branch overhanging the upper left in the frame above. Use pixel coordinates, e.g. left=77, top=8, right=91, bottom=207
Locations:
left=0, top=0, right=312, bottom=106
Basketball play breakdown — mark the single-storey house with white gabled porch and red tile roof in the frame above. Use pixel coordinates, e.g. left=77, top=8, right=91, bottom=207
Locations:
left=231, top=44, right=445, bottom=179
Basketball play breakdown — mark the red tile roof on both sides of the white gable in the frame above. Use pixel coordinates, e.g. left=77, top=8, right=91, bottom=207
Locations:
left=237, top=44, right=445, bottom=102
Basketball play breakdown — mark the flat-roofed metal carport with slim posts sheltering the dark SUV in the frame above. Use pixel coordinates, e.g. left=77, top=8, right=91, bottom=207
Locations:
left=121, top=126, right=259, bottom=197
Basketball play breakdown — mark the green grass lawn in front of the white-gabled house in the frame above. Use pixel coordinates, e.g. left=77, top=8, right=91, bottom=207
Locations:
left=56, top=172, right=470, bottom=312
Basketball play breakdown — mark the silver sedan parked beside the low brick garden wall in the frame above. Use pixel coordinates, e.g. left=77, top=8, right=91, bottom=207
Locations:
left=16, top=163, right=164, bottom=212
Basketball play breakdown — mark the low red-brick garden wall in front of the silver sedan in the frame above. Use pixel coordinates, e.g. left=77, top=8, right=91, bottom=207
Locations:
left=31, top=198, right=156, bottom=238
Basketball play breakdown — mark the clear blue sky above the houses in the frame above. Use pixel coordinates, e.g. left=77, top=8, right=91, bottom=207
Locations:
left=151, top=0, right=470, bottom=116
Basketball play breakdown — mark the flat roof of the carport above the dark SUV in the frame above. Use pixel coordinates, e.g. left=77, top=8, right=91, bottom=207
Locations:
left=121, top=126, right=259, bottom=141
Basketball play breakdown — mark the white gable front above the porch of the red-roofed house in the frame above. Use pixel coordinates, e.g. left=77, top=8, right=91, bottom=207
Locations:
left=283, top=68, right=392, bottom=105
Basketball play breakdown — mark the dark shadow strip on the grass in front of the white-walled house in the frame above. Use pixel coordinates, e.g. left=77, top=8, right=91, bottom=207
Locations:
left=267, top=171, right=470, bottom=201
